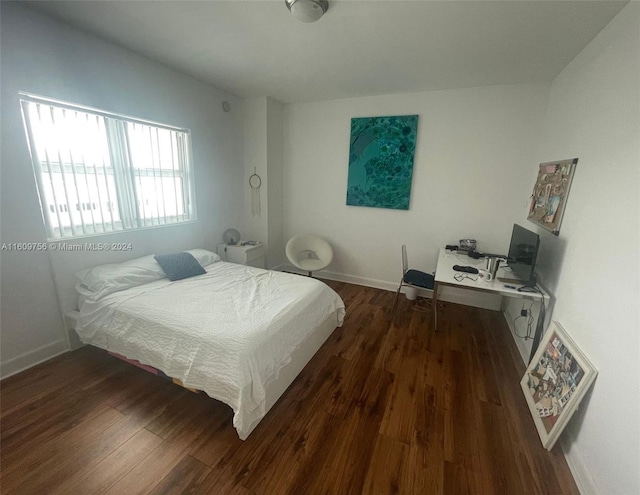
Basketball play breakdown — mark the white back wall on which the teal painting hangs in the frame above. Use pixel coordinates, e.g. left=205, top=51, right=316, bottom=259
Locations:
left=284, top=84, right=548, bottom=306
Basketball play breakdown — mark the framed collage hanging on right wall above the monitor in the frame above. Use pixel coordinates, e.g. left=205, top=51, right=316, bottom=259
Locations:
left=527, top=158, right=578, bottom=235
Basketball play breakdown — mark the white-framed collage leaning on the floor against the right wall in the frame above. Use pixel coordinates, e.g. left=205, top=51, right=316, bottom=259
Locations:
left=520, top=321, right=598, bottom=450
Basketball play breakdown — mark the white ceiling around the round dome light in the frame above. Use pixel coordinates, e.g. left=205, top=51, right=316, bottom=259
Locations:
left=24, top=0, right=627, bottom=103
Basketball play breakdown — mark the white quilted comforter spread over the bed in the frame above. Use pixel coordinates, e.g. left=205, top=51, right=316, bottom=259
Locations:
left=76, top=262, right=344, bottom=439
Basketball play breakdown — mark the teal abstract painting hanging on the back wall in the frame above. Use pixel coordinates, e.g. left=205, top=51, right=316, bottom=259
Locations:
left=347, top=115, right=418, bottom=210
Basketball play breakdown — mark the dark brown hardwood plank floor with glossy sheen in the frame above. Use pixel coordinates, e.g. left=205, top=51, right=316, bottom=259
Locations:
left=0, top=282, right=578, bottom=495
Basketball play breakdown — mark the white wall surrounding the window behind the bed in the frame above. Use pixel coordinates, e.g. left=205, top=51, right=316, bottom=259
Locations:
left=1, top=2, right=244, bottom=376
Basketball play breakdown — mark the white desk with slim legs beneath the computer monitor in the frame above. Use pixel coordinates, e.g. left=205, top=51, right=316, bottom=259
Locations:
left=433, top=248, right=549, bottom=360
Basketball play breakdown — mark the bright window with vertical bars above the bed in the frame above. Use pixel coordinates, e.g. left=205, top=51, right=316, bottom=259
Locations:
left=20, top=94, right=195, bottom=239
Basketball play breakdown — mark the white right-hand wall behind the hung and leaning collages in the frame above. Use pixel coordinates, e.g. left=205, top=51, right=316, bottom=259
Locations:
left=522, top=2, right=640, bottom=495
